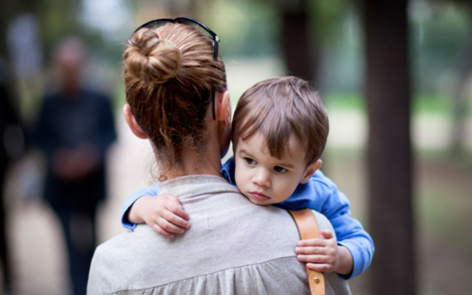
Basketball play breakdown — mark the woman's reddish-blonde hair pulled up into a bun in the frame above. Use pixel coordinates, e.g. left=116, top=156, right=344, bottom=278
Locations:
left=123, top=23, right=226, bottom=178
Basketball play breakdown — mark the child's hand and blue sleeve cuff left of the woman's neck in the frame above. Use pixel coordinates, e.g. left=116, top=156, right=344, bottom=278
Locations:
left=121, top=184, right=190, bottom=237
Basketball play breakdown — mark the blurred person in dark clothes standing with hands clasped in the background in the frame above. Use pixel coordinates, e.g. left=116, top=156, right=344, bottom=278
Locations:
left=34, top=37, right=116, bottom=295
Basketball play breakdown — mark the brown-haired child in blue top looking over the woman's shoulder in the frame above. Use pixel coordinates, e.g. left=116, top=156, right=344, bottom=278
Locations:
left=122, top=77, right=374, bottom=279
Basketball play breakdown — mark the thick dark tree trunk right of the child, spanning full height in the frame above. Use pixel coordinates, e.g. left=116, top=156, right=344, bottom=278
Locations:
left=362, top=0, right=416, bottom=295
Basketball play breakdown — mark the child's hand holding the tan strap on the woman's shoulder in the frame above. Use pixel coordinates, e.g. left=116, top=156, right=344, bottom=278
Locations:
left=295, top=230, right=353, bottom=275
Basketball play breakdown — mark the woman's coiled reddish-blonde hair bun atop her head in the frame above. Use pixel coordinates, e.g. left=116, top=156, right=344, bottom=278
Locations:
left=123, top=28, right=182, bottom=84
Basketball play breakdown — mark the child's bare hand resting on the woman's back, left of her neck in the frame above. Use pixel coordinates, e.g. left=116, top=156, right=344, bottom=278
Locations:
left=128, top=194, right=190, bottom=238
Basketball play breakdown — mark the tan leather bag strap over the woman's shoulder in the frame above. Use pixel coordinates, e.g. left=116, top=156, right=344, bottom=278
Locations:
left=288, top=209, right=325, bottom=295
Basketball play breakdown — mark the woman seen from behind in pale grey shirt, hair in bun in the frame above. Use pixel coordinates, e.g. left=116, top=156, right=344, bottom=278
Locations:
left=88, top=18, right=348, bottom=294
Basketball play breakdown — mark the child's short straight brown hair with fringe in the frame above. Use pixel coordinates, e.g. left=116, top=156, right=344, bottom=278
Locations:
left=232, top=76, right=329, bottom=165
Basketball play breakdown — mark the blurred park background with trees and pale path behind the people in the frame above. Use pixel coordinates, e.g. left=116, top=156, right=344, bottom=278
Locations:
left=0, top=0, right=472, bottom=295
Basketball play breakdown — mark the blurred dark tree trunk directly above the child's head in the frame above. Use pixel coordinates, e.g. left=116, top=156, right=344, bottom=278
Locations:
left=279, top=0, right=319, bottom=83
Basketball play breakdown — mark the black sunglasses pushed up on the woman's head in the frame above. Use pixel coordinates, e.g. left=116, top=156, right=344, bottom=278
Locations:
left=134, top=17, right=220, bottom=120
